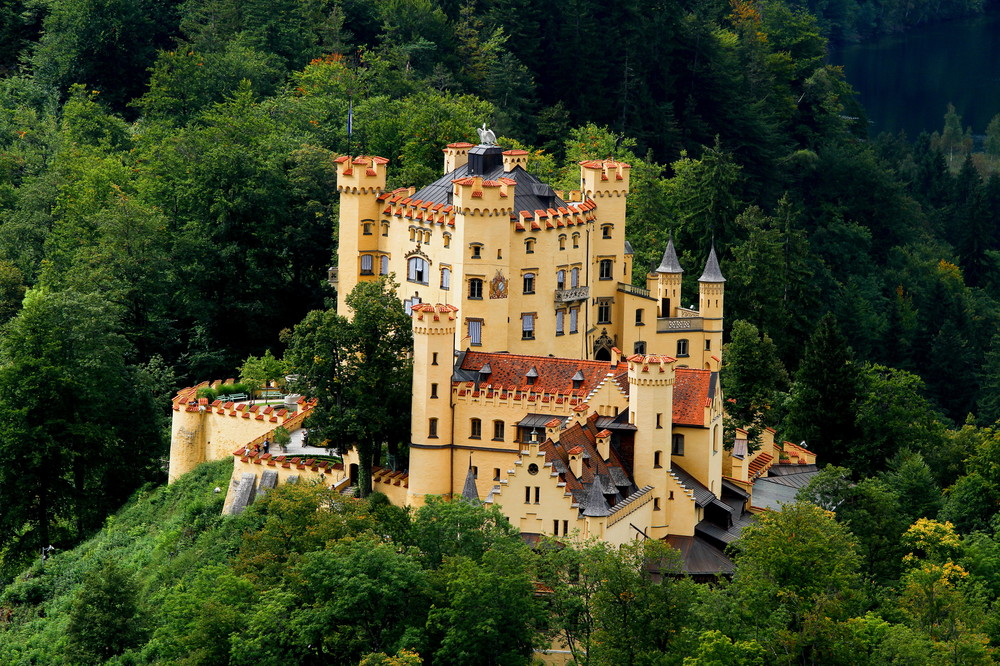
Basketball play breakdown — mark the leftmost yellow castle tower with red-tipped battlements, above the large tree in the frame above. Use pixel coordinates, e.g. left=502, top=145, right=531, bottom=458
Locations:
left=335, top=155, right=389, bottom=315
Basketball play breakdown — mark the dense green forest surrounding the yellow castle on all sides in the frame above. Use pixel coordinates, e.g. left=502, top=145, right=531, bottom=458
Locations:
left=0, top=0, right=1000, bottom=666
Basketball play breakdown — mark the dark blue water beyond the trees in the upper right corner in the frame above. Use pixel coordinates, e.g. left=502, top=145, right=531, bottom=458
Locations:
left=830, top=12, right=1000, bottom=139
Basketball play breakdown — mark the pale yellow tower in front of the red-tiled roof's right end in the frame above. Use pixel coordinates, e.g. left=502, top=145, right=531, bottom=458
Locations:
left=628, top=354, right=676, bottom=539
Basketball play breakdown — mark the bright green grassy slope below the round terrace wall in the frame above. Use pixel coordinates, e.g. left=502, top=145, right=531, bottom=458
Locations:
left=0, top=460, right=242, bottom=665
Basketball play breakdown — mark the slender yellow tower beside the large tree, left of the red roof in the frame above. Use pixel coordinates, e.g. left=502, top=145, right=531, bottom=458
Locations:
left=406, top=303, right=458, bottom=506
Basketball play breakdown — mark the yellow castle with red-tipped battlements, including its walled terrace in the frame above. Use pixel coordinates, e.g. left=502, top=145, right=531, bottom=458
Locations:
left=171, top=134, right=815, bottom=576
